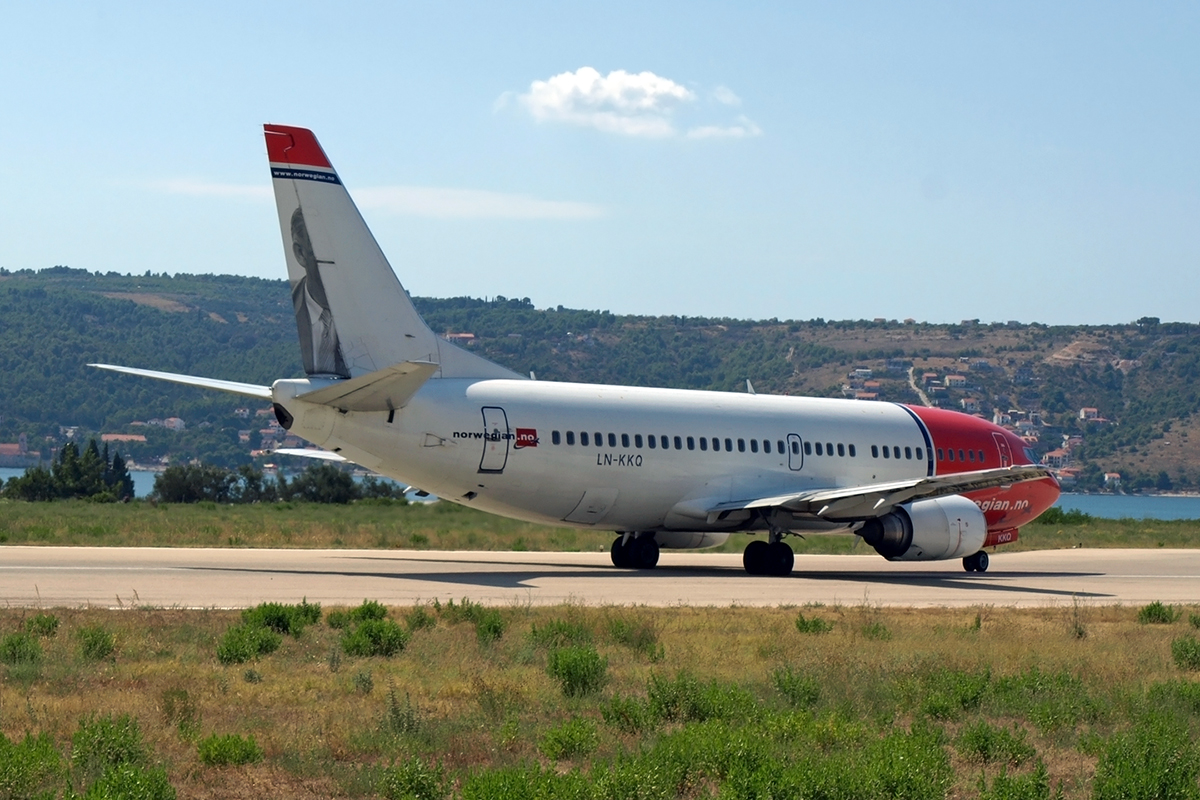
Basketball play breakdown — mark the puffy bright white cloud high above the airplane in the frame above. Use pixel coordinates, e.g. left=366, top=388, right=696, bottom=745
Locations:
left=516, top=67, right=696, bottom=138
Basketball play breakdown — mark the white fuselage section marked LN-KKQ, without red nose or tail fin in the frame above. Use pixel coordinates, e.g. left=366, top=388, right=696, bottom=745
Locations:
left=275, top=379, right=932, bottom=531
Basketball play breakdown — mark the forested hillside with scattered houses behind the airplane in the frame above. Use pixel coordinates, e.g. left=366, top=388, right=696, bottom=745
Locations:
left=0, top=267, right=1200, bottom=487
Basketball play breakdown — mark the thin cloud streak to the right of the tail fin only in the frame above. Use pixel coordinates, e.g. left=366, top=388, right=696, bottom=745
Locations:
left=354, top=186, right=606, bottom=219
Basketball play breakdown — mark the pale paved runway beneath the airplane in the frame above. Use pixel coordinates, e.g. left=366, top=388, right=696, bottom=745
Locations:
left=0, top=547, right=1200, bottom=608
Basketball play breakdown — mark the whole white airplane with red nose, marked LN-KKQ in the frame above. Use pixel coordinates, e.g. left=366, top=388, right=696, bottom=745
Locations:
left=90, top=125, right=1060, bottom=576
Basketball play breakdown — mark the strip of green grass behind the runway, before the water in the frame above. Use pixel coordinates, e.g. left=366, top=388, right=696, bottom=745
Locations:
left=0, top=500, right=1200, bottom=553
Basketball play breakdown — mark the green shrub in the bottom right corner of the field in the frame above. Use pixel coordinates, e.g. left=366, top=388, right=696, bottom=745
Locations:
left=1092, top=711, right=1200, bottom=800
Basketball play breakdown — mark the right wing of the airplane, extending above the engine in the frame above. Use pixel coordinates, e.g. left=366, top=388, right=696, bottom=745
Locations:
left=708, top=464, right=1051, bottom=522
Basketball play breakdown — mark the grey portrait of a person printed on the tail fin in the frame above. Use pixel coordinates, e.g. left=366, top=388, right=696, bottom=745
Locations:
left=292, top=209, right=350, bottom=378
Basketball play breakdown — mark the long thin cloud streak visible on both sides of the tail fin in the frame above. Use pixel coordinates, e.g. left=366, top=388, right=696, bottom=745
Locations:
left=150, top=179, right=607, bottom=219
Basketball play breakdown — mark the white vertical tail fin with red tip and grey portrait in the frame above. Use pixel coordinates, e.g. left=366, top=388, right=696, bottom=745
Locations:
left=264, top=125, right=518, bottom=379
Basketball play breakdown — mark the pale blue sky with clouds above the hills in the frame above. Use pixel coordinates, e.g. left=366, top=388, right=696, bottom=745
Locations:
left=0, top=0, right=1200, bottom=323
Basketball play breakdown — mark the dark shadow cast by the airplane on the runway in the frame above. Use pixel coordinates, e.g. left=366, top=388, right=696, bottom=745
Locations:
left=196, top=557, right=1114, bottom=599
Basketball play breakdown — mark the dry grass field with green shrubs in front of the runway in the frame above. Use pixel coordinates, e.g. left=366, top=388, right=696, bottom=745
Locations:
left=0, top=601, right=1200, bottom=800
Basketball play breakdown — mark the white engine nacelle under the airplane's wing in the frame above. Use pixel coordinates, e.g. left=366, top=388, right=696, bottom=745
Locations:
left=858, top=494, right=988, bottom=561
